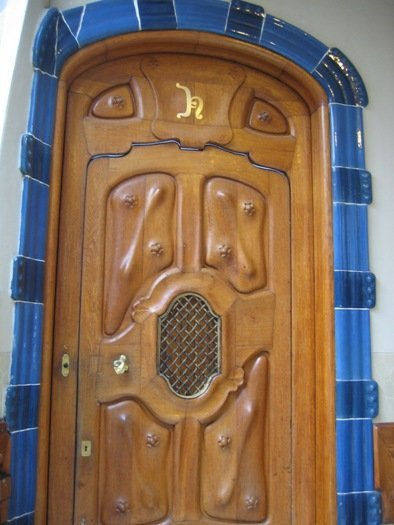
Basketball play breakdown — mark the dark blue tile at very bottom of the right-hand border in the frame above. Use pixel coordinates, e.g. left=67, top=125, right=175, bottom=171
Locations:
left=337, top=491, right=382, bottom=525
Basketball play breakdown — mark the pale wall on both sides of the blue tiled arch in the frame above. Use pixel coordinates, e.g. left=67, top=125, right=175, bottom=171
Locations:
left=0, top=0, right=394, bottom=421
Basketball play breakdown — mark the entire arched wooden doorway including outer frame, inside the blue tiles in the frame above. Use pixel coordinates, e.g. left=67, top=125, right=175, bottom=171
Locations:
left=37, top=31, right=336, bottom=523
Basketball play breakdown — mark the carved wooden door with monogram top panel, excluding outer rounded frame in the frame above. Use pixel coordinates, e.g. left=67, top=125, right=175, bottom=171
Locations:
left=48, top=46, right=330, bottom=525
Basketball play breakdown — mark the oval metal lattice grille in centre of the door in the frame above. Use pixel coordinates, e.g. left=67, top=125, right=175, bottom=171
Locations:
left=158, top=293, right=220, bottom=398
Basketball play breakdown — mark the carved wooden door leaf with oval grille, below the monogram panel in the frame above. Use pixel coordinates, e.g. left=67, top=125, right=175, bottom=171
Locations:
left=76, top=144, right=291, bottom=524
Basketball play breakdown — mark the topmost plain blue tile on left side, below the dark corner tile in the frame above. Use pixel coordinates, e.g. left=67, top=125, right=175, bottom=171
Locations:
left=28, top=71, right=57, bottom=144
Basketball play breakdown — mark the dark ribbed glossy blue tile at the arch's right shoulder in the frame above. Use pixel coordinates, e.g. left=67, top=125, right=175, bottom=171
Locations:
left=313, top=48, right=368, bottom=106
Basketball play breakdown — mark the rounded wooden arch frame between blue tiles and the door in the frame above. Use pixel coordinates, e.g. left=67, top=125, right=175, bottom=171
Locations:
left=36, top=31, right=336, bottom=524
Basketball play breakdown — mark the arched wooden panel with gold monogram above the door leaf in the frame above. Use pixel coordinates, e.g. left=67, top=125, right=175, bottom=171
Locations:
left=78, top=53, right=298, bottom=167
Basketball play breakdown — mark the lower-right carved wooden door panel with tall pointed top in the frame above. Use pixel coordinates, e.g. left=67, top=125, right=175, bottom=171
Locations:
left=201, top=354, right=268, bottom=522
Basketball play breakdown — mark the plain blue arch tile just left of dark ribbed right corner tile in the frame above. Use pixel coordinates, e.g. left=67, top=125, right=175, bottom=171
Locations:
left=260, top=15, right=328, bottom=72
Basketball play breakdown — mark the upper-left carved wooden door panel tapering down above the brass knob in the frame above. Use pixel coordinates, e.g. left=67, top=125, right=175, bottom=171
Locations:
left=104, top=174, right=175, bottom=335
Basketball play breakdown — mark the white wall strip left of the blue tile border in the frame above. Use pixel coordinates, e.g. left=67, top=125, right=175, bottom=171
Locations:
left=0, top=0, right=47, bottom=415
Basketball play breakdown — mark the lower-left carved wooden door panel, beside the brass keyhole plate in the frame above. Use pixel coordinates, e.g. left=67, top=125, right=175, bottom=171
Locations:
left=99, top=400, right=173, bottom=525
